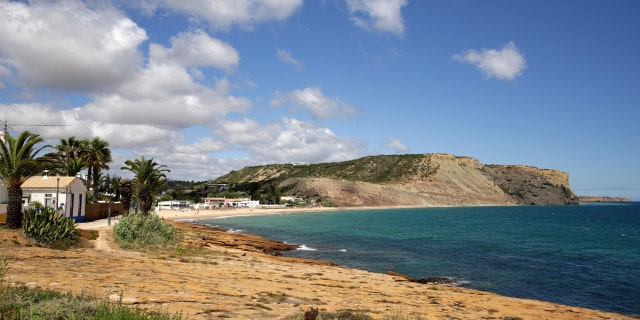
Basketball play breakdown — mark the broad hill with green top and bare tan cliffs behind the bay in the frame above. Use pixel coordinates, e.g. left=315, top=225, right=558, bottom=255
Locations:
left=213, top=154, right=579, bottom=207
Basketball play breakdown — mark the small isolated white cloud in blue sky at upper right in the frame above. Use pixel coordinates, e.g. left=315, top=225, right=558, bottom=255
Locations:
left=452, top=41, right=527, bottom=80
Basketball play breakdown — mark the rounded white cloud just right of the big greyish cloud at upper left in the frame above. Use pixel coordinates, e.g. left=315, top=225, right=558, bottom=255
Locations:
left=149, top=30, right=240, bottom=71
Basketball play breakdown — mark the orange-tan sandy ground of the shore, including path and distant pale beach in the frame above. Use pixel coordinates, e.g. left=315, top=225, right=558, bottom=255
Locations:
left=0, top=209, right=633, bottom=319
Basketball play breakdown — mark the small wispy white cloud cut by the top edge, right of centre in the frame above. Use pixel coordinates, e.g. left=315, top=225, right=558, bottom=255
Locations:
left=346, top=0, right=408, bottom=35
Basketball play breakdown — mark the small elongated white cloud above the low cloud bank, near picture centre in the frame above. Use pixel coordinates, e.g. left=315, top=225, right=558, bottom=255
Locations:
left=271, top=87, right=356, bottom=120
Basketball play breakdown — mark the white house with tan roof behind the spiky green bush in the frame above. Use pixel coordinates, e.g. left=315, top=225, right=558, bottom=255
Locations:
left=22, top=176, right=87, bottom=222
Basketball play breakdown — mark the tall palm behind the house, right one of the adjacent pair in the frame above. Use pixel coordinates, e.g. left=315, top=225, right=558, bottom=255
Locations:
left=80, top=137, right=112, bottom=197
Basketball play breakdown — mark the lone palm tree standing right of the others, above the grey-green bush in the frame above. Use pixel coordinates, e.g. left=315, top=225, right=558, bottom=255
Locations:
left=121, top=156, right=171, bottom=216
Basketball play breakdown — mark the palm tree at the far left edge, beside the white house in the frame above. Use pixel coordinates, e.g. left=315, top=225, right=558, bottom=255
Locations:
left=0, top=131, right=49, bottom=229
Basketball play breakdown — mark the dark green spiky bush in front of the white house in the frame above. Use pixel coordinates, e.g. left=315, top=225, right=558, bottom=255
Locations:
left=22, top=208, right=78, bottom=244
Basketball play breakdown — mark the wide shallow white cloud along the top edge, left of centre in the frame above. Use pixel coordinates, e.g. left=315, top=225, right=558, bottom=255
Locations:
left=132, top=0, right=303, bottom=30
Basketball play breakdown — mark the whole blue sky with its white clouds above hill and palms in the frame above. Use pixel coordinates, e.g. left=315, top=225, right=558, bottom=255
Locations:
left=0, top=0, right=640, bottom=201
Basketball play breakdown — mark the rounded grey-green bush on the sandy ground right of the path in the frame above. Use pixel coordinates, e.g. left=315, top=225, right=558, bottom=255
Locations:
left=113, top=213, right=176, bottom=248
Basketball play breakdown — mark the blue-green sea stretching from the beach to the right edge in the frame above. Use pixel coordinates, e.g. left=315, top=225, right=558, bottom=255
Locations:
left=199, top=203, right=640, bottom=315
